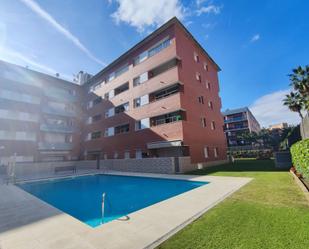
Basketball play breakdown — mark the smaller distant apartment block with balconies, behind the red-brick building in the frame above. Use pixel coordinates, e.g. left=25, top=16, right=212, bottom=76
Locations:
left=222, top=107, right=261, bottom=146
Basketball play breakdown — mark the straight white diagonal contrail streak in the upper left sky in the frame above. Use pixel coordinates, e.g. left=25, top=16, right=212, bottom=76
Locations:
left=20, top=0, right=106, bottom=66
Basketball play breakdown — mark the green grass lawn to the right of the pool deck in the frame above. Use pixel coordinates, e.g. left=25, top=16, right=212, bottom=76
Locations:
left=158, top=160, right=309, bottom=249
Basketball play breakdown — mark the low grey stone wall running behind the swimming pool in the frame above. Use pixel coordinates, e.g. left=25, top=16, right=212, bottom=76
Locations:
left=9, top=157, right=226, bottom=179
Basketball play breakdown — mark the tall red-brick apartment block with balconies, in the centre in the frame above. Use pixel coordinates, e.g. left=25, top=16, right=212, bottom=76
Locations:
left=81, top=18, right=226, bottom=163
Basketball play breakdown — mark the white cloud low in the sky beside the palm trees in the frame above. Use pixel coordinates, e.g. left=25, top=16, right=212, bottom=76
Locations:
left=249, top=89, right=300, bottom=127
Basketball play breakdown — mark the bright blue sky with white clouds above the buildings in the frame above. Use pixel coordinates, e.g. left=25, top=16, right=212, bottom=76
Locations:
left=0, top=0, right=309, bottom=127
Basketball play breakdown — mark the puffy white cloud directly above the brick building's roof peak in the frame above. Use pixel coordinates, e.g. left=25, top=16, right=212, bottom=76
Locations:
left=112, top=0, right=185, bottom=32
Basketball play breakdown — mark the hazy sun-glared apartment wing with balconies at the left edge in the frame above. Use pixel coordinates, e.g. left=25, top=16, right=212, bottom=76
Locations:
left=0, top=61, right=82, bottom=164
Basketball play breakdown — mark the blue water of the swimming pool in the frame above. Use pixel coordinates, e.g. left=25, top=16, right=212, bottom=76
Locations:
left=18, top=175, right=207, bottom=227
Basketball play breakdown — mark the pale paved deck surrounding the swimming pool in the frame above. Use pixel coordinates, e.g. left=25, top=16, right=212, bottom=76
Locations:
left=0, top=172, right=251, bottom=249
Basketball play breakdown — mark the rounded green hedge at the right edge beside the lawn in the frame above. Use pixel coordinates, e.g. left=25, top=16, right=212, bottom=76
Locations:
left=291, top=139, right=309, bottom=179
